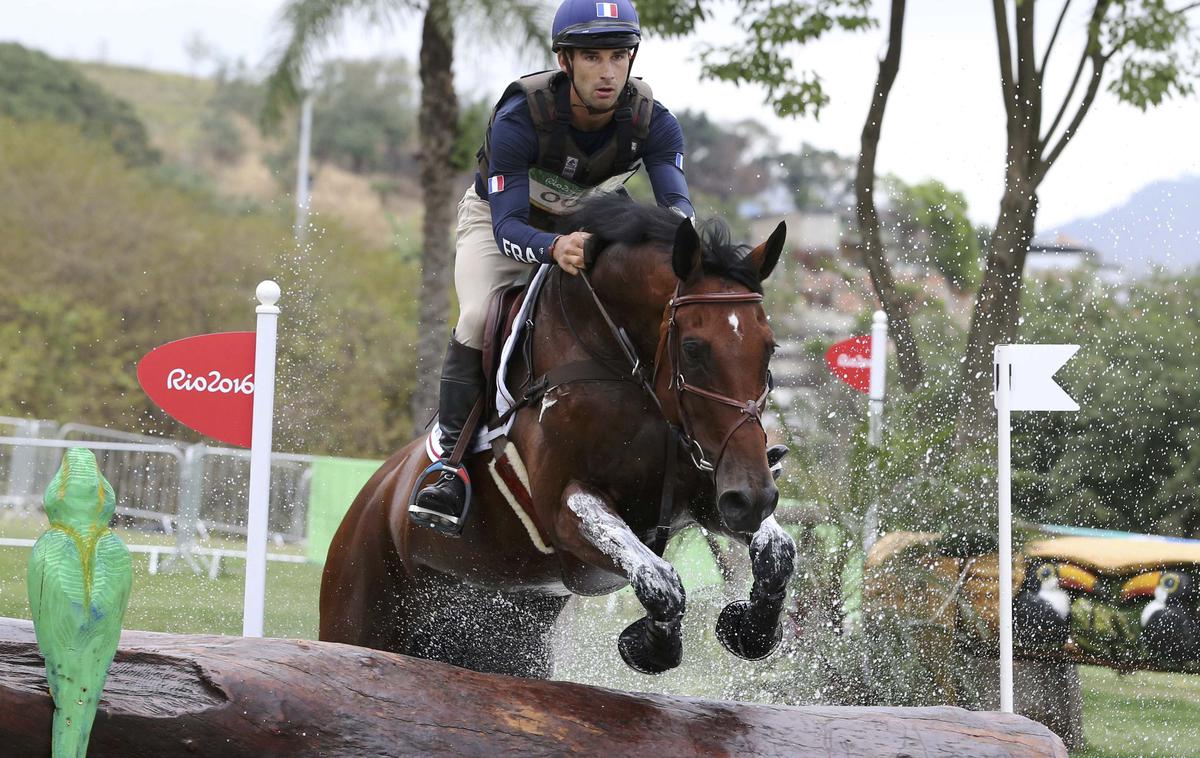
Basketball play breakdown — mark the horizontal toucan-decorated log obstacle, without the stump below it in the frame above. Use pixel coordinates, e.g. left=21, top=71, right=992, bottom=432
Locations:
left=868, top=533, right=1200, bottom=673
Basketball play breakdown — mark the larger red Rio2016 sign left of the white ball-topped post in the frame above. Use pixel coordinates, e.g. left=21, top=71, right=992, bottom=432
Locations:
left=138, top=332, right=254, bottom=447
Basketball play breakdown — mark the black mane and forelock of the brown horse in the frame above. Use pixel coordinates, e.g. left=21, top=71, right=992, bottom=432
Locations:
left=562, top=194, right=762, bottom=294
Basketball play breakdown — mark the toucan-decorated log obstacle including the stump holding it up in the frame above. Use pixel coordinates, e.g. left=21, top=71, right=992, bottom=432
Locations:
left=864, top=530, right=1200, bottom=748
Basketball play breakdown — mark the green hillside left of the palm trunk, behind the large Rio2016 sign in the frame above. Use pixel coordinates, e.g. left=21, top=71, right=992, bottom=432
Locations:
left=0, top=44, right=419, bottom=457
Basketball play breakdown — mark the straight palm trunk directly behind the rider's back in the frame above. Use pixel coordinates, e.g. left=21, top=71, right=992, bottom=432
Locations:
left=410, top=0, right=458, bottom=437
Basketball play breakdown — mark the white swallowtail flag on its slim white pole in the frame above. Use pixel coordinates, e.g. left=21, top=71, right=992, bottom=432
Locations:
left=992, top=344, right=1079, bottom=714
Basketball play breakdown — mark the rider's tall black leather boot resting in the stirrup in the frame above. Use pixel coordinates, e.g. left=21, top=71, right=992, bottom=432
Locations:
left=408, top=339, right=485, bottom=535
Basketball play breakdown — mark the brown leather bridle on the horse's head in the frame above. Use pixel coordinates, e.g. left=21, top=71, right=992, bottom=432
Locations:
left=650, top=284, right=772, bottom=475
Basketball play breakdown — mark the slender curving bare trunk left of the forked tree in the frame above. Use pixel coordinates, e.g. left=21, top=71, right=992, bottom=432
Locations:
left=854, top=0, right=925, bottom=392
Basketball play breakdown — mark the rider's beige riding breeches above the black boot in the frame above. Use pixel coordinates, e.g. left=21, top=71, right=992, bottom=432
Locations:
left=454, top=185, right=536, bottom=350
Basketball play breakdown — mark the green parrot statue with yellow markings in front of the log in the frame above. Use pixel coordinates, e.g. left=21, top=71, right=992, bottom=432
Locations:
left=29, top=447, right=133, bottom=758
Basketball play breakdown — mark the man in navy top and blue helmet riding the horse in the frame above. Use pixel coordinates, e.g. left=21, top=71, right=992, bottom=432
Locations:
left=409, top=0, right=695, bottom=535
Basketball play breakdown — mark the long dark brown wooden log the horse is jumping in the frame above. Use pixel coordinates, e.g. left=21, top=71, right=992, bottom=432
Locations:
left=0, top=618, right=1067, bottom=758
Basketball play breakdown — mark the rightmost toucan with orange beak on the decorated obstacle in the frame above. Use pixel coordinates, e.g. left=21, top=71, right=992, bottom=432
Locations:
left=1121, top=571, right=1200, bottom=663
